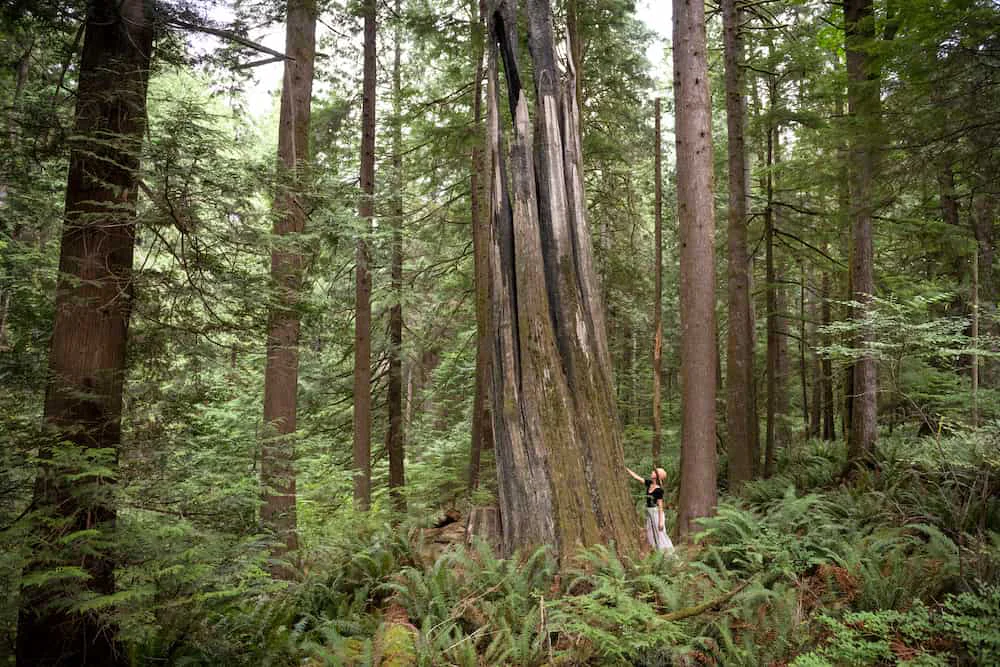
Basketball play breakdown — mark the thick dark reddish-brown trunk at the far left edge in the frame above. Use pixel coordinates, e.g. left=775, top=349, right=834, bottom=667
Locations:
left=16, top=0, right=153, bottom=665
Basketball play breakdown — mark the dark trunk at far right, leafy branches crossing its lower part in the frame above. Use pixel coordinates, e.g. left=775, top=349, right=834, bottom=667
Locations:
left=844, top=0, right=879, bottom=464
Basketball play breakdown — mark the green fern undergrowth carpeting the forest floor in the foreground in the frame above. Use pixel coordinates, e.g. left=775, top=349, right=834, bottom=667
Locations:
left=7, top=429, right=1000, bottom=667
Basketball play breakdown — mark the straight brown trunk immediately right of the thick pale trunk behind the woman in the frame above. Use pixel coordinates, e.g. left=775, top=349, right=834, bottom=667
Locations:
left=722, top=0, right=754, bottom=492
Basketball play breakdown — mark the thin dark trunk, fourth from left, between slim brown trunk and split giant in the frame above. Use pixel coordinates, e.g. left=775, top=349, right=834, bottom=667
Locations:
left=385, top=0, right=406, bottom=514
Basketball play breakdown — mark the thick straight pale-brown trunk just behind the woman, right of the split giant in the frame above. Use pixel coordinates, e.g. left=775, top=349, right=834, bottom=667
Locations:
left=673, top=0, right=717, bottom=535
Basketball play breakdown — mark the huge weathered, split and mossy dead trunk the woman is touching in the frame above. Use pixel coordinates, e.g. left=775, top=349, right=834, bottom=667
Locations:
left=487, top=0, right=639, bottom=562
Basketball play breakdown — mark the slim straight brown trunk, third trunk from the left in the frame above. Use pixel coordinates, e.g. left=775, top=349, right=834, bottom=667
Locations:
left=354, top=0, right=376, bottom=511
